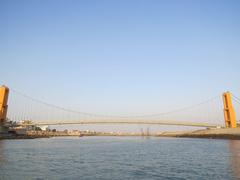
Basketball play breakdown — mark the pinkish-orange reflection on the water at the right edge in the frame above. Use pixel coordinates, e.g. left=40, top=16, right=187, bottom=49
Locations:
left=229, top=140, right=240, bottom=178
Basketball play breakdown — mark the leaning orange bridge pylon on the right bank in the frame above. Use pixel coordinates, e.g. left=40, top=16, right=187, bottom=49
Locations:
left=223, top=92, right=237, bottom=128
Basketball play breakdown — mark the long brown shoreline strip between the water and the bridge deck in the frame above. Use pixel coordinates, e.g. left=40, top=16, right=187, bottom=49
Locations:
left=0, top=128, right=240, bottom=140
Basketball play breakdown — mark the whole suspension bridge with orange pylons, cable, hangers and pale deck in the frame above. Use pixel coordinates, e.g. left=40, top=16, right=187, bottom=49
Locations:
left=0, top=86, right=240, bottom=128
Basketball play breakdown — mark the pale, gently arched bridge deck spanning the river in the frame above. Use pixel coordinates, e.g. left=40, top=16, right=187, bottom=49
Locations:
left=29, top=119, right=222, bottom=128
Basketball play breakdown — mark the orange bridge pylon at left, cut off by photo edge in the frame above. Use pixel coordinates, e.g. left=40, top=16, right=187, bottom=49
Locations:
left=0, top=86, right=9, bottom=123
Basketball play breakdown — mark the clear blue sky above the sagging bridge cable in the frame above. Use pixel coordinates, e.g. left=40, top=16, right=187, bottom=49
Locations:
left=0, top=0, right=240, bottom=114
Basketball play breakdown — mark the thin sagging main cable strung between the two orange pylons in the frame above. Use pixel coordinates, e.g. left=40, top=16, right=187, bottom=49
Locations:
left=12, top=89, right=220, bottom=118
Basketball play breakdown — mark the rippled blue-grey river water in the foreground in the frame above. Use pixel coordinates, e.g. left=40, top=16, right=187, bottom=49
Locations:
left=0, top=137, right=240, bottom=180
